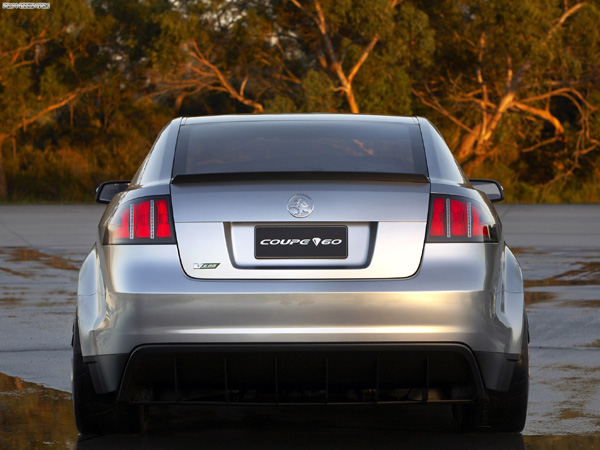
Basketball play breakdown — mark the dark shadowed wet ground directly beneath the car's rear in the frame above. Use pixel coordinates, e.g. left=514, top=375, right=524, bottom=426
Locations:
left=77, top=405, right=525, bottom=450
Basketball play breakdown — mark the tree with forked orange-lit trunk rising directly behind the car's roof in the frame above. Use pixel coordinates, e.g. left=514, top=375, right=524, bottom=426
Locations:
left=281, top=0, right=433, bottom=114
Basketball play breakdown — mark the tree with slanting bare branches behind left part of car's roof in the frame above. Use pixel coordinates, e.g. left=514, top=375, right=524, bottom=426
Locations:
left=150, top=0, right=299, bottom=113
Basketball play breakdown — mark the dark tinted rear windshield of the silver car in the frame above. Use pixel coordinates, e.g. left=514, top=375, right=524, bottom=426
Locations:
left=173, top=120, right=427, bottom=176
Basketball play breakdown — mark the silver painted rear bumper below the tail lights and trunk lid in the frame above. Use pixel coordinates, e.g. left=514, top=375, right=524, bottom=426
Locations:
left=78, top=244, right=524, bottom=398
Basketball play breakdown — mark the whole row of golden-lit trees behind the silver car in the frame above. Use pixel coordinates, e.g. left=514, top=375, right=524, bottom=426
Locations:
left=0, top=0, right=600, bottom=202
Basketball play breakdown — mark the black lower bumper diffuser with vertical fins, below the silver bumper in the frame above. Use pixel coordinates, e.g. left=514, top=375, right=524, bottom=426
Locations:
left=84, top=343, right=514, bottom=405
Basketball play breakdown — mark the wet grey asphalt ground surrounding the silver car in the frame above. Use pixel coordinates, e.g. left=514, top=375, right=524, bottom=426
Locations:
left=0, top=204, right=600, bottom=450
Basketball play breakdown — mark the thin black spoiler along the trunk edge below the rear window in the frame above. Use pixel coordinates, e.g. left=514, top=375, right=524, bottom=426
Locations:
left=171, top=172, right=429, bottom=184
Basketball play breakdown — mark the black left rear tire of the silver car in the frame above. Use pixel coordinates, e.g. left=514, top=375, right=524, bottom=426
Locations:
left=71, top=318, right=145, bottom=435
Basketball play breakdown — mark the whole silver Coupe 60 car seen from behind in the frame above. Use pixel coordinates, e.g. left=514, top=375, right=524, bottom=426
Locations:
left=73, top=114, right=529, bottom=434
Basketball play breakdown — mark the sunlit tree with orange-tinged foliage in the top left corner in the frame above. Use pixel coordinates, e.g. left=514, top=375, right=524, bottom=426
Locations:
left=0, top=0, right=93, bottom=201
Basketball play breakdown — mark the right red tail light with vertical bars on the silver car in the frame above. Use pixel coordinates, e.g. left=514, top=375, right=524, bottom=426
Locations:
left=427, top=195, right=498, bottom=242
